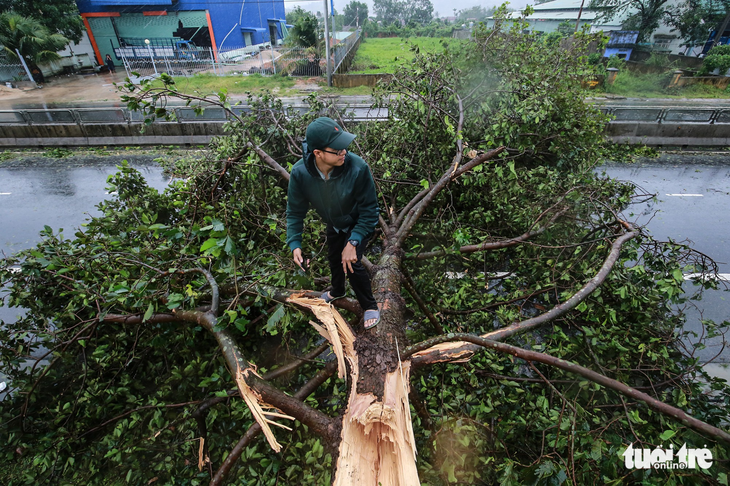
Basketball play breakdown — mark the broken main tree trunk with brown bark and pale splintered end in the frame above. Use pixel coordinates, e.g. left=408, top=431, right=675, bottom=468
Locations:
left=288, top=266, right=420, bottom=486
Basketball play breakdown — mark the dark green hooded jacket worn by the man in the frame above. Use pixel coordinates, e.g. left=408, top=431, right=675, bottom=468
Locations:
left=286, top=152, right=379, bottom=251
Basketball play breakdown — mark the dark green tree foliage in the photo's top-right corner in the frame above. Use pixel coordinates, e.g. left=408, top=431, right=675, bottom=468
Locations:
left=667, top=0, right=730, bottom=47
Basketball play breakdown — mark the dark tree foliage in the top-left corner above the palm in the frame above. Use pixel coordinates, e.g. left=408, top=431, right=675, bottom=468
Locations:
left=0, top=0, right=85, bottom=42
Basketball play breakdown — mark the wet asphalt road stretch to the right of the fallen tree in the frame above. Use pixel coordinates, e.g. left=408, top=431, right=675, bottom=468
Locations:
left=603, top=153, right=730, bottom=363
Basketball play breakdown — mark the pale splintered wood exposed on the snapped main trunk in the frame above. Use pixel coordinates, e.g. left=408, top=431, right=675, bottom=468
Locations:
left=289, top=297, right=420, bottom=486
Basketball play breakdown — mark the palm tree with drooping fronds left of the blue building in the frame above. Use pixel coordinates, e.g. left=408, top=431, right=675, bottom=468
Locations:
left=0, top=11, right=71, bottom=81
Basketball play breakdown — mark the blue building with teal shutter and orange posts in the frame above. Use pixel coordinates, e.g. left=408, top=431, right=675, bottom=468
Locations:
left=76, top=0, right=287, bottom=64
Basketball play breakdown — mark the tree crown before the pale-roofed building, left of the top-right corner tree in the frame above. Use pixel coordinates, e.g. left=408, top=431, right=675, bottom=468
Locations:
left=591, top=0, right=669, bottom=42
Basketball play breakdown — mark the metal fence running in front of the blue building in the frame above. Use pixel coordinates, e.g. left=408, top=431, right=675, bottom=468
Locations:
left=114, top=30, right=360, bottom=77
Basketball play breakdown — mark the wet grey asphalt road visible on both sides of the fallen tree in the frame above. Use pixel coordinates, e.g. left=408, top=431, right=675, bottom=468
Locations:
left=0, top=153, right=730, bottom=363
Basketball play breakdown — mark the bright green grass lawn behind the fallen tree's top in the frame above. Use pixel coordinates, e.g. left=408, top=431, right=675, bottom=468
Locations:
left=350, top=37, right=464, bottom=74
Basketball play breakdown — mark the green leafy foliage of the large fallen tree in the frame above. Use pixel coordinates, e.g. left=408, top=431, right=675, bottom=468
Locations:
left=0, top=4, right=730, bottom=486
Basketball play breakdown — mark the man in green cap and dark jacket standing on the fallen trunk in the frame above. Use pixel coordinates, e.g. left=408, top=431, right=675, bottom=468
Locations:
left=286, top=117, right=380, bottom=329
